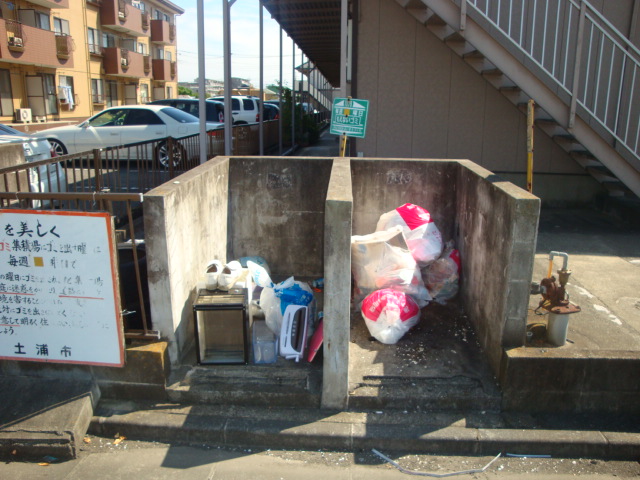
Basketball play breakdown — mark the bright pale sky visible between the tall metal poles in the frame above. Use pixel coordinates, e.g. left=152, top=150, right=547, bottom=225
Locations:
left=174, top=0, right=302, bottom=87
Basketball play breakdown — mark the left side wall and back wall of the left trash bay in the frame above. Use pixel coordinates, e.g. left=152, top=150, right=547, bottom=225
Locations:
left=144, top=157, right=332, bottom=364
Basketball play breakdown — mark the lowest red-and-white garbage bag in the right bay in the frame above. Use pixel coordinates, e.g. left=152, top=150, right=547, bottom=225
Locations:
left=360, top=289, right=420, bottom=345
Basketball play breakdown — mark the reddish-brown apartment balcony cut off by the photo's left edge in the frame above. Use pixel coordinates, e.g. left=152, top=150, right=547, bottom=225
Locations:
left=0, top=19, right=73, bottom=68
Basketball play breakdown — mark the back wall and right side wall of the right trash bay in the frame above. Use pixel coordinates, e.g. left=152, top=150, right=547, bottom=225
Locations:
left=351, top=159, right=540, bottom=375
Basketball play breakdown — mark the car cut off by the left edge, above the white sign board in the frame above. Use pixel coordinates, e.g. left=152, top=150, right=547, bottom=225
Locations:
left=0, top=124, right=67, bottom=198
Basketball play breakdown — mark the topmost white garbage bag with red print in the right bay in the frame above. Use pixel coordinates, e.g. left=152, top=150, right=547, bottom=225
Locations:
left=376, top=203, right=442, bottom=267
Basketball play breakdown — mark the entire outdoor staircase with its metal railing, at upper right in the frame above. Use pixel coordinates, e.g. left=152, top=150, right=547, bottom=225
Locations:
left=396, top=0, right=640, bottom=198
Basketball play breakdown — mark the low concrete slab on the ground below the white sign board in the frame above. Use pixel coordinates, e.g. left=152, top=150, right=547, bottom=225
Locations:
left=0, top=376, right=100, bottom=460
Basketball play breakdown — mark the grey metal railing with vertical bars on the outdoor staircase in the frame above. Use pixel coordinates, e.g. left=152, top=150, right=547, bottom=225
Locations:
left=457, top=0, right=640, bottom=166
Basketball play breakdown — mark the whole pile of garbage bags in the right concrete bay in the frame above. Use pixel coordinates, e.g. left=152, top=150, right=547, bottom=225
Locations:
left=351, top=203, right=460, bottom=344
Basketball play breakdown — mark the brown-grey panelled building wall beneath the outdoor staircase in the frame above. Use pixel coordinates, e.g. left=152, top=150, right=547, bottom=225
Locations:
left=354, top=0, right=601, bottom=203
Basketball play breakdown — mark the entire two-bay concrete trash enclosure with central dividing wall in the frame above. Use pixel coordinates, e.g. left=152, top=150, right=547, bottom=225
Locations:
left=144, top=157, right=540, bottom=408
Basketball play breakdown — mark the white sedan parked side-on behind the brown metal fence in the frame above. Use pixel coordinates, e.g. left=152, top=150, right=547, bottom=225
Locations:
left=40, top=105, right=224, bottom=166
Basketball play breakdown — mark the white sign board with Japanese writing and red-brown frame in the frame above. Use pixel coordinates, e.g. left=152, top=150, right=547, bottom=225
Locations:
left=0, top=210, right=124, bottom=366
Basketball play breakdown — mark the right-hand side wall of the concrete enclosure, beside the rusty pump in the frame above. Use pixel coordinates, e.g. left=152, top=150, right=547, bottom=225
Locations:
left=455, top=161, right=540, bottom=376
